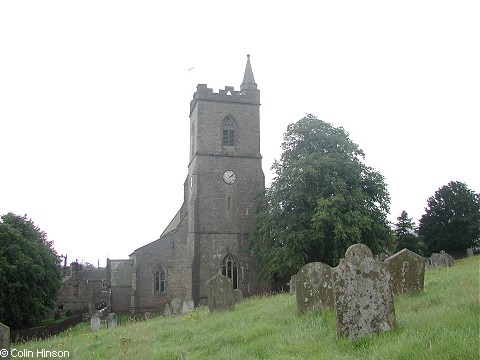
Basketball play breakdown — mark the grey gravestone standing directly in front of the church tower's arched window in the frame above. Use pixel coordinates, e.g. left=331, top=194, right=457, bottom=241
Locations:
left=207, top=274, right=235, bottom=312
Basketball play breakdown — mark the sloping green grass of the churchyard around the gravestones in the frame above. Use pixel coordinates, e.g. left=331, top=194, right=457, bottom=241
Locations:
left=11, top=256, right=480, bottom=359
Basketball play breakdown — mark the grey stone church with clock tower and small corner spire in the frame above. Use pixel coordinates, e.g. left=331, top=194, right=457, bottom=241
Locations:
left=107, top=55, right=270, bottom=313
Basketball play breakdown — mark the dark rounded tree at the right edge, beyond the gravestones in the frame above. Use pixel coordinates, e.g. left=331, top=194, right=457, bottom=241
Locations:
left=419, top=181, right=480, bottom=254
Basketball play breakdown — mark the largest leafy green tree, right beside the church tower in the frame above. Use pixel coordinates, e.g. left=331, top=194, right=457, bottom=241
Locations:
left=248, top=114, right=392, bottom=279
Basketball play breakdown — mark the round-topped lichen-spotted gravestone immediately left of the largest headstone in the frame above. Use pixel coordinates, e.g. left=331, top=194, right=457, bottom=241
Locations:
left=295, top=262, right=334, bottom=314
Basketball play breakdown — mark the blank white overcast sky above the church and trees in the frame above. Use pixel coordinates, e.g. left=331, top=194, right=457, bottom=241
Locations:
left=0, top=0, right=480, bottom=265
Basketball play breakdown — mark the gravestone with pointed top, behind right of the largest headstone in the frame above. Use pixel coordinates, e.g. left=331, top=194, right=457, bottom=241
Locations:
left=385, top=249, right=425, bottom=294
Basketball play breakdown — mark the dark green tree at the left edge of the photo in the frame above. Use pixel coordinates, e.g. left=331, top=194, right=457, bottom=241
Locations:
left=0, top=213, right=61, bottom=329
